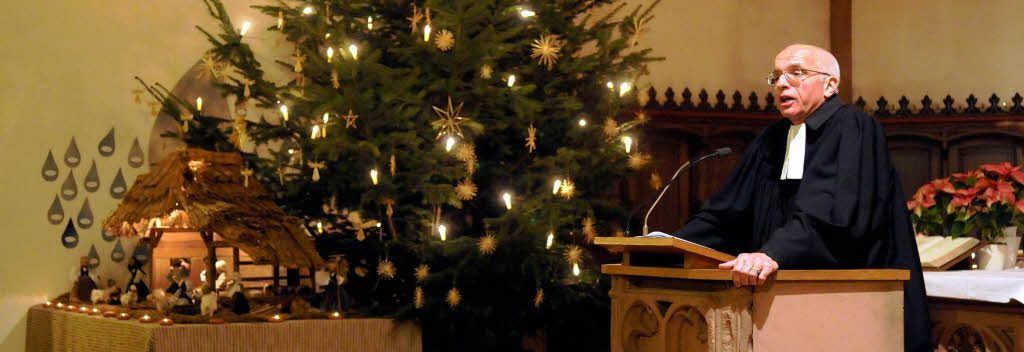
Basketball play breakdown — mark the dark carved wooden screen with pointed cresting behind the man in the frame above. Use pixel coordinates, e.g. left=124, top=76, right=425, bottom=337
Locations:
left=623, top=88, right=1024, bottom=233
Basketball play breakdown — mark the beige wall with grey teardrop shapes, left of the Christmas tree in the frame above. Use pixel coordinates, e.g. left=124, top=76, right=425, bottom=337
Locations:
left=0, top=0, right=269, bottom=351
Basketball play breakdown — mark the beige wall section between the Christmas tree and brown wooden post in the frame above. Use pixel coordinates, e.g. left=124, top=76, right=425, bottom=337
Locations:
left=629, top=0, right=829, bottom=103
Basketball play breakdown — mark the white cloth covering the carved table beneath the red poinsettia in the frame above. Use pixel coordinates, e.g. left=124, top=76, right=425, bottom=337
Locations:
left=925, top=269, right=1024, bottom=303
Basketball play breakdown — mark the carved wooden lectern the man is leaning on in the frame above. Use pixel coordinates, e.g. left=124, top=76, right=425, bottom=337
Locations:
left=594, top=237, right=910, bottom=352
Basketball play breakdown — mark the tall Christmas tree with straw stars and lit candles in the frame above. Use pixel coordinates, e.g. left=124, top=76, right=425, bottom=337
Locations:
left=136, top=0, right=658, bottom=350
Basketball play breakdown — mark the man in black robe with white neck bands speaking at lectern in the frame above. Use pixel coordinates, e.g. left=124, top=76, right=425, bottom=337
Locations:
left=675, top=44, right=931, bottom=351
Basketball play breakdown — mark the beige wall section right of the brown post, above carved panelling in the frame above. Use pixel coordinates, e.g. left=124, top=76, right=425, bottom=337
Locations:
left=853, top=0, right=1024, bottom=107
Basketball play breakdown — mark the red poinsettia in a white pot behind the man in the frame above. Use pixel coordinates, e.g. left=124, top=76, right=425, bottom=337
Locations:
left=906, top=163, right=1024, bottom=270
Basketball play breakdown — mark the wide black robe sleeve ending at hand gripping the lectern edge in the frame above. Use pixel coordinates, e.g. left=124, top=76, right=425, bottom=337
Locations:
left=760, top=107, right=892, bottom=268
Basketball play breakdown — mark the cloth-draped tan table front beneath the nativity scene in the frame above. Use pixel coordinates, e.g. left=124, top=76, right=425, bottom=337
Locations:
left=26, top=305, right=423, bottom=352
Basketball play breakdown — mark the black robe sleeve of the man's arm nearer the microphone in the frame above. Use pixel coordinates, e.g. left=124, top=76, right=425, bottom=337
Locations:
left=673, top=134, right=764, bottom=254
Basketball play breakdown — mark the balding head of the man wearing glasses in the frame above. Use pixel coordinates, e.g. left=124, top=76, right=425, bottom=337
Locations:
left=773, top=44, right=840, bottom=124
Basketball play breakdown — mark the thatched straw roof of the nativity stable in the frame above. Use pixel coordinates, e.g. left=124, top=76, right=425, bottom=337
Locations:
left=103, top=149, right=324, bottom=267
